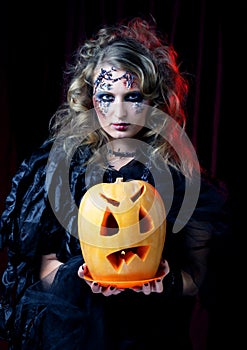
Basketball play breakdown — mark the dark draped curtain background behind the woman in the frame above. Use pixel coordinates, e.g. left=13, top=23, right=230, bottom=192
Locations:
left=0, top=0, right=243, bottom=350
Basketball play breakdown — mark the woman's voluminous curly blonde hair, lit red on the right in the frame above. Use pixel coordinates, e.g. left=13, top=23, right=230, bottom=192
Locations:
left=50, top=17, right=197, bottom=176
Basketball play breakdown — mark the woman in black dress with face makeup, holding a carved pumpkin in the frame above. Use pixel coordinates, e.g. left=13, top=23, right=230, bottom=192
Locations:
left=1, top=18, right=228, bottom=350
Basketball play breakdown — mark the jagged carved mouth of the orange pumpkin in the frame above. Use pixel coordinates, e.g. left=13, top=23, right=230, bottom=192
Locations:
left=107, top=245, right=150, bottom=271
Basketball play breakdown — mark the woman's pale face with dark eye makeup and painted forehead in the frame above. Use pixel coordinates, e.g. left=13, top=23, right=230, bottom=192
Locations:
left=93, top=65, right=149, bottom=139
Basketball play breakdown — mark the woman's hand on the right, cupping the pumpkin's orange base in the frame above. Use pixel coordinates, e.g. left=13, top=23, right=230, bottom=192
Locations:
left=131, top=260, right=170, bottom=295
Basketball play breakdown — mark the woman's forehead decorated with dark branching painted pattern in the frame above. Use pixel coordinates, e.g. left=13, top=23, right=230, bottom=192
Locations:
left=93, top=64, right=139, bottom=90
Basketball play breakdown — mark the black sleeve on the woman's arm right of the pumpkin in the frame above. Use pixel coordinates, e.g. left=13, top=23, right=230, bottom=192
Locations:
left=164, top=171, right=229, bottom=298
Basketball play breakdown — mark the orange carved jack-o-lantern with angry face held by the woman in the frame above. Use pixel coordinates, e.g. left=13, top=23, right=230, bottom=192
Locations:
left=78, top=178, right=166, bottom=285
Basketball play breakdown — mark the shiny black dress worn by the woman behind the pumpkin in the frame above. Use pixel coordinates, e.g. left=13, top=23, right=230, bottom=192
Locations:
left=0, top=141, right=230, bottom=350
